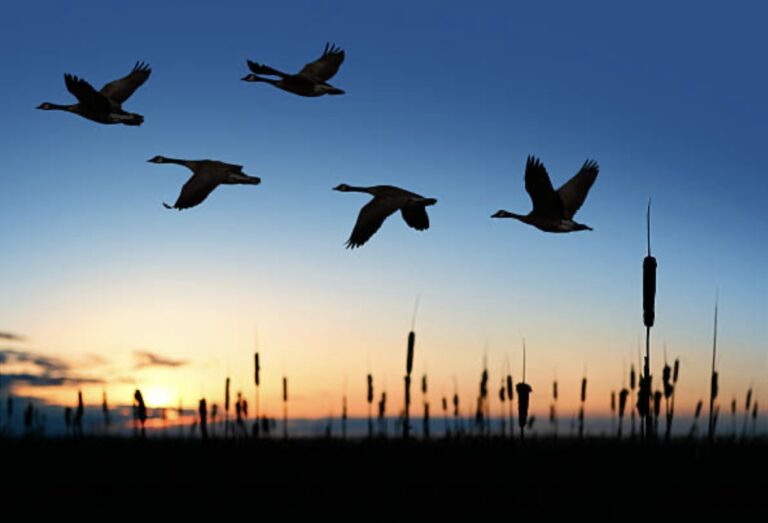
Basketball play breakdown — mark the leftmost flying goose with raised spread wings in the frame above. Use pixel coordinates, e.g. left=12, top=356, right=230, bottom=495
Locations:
left=37, top=62, right=152, bottom=125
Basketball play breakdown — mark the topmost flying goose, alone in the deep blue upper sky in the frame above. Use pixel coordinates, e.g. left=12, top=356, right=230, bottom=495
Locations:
left=242, top=44, right=344, bottom=96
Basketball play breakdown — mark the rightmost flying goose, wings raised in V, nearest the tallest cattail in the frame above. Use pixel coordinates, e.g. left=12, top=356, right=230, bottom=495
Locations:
left=491, top=156, right=598, bottom=232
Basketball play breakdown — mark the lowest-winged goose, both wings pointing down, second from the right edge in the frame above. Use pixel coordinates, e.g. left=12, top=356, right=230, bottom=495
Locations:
left=333, top=183, right=437, bottom=249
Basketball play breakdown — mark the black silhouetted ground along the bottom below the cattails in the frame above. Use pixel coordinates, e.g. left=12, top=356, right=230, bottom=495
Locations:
left=0, top=438, right=768, bottom=519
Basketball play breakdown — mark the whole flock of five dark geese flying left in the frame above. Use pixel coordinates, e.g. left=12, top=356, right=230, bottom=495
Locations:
left=37, top=43, right=599, bottom=249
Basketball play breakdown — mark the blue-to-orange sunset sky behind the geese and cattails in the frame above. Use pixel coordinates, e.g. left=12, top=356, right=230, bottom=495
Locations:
left=0, top=1, right=768, bottom=426
